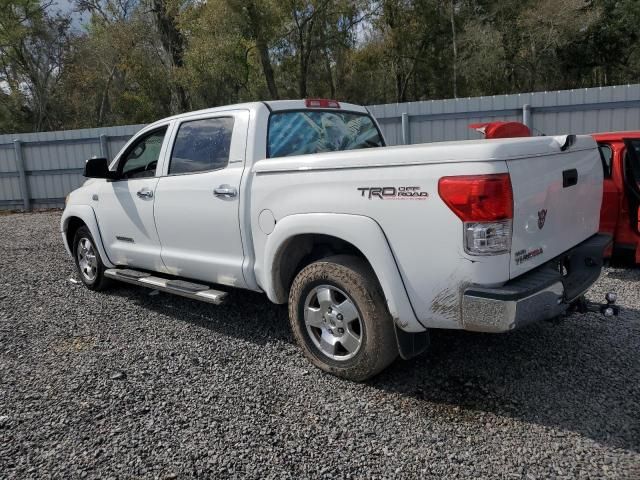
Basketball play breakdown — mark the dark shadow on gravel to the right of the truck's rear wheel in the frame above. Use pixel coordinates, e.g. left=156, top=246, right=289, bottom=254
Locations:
left=370, top=316, right=640, bottom=452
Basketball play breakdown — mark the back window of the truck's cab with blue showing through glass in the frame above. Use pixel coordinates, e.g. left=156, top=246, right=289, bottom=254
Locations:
left=267, top=110, right=384, bottom=158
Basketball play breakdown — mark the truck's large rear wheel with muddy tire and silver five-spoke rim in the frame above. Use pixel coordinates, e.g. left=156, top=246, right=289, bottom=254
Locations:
left=289, top=255, right=398, bottom=382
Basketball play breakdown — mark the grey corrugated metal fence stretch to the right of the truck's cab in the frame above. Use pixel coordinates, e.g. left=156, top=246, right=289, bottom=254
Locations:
left=370, top=85, right=640, bottom=145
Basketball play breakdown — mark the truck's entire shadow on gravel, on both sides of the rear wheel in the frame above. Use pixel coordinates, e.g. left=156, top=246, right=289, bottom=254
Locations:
left=108, top=287, right=640, bottom=452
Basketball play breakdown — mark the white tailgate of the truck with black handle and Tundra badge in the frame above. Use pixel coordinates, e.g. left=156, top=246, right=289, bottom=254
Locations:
left=507, top=136, right=603, bottom=278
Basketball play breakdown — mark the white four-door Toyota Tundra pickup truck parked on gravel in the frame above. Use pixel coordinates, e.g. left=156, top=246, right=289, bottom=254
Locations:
left=61, top=99, right=610, bottom=380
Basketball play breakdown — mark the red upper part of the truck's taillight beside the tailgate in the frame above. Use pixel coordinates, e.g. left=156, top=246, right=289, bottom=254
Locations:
left=438, top=173, right=513, bottom=222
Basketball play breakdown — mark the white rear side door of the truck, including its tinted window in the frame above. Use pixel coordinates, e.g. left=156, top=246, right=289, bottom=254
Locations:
left=155, top=111, right=249, bottom=287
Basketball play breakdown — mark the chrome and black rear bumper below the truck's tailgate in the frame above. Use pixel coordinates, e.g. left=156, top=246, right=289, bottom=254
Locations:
left=462, top=234, right=611, bottom=332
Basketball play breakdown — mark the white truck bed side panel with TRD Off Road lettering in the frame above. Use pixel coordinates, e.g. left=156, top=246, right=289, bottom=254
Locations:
left=251, top=158, right=509, bottom=328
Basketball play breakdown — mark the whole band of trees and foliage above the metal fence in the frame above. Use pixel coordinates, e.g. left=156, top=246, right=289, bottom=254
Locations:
left=0, top=0, right=640, bottom=132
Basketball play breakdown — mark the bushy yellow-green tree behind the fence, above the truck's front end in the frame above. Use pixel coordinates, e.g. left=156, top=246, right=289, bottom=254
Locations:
left=63, top=2, right=172, bottom=128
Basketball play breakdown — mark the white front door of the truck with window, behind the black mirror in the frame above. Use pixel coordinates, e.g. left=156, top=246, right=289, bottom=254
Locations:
left=94, top=126, right=167, bottom=271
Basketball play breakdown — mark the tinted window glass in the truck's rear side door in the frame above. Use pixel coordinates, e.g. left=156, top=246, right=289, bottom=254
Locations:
left=169, top=117, right=233, bottom=175
